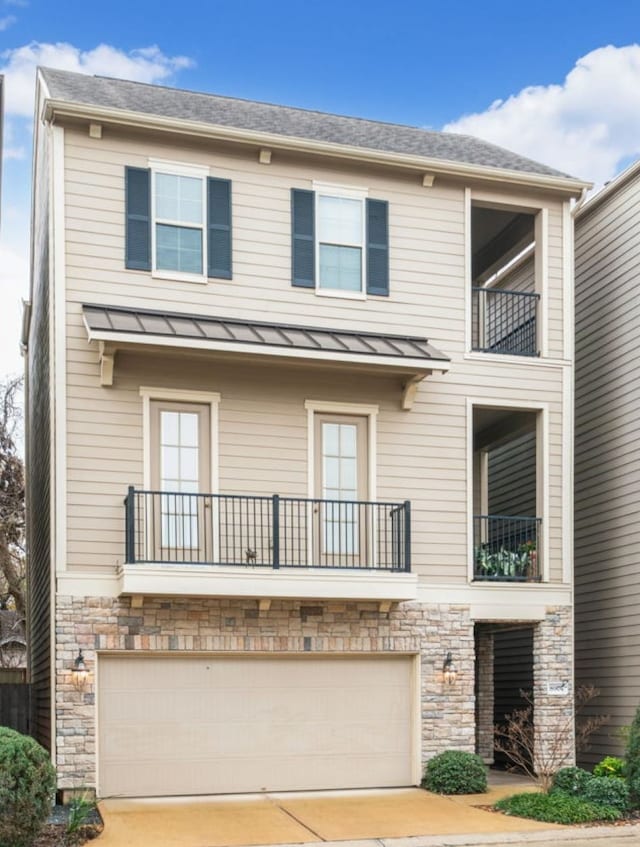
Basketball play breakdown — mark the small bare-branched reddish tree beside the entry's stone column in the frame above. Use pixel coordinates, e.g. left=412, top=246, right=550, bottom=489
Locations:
left=495, top=685, right=608, bottom=793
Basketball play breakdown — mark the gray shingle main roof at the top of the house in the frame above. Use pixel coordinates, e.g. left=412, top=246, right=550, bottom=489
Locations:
left=41, top=68, right=567, bottom=177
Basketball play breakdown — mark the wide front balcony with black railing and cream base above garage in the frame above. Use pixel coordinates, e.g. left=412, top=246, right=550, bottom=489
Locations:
left=120, top=488, right=417, bottom=602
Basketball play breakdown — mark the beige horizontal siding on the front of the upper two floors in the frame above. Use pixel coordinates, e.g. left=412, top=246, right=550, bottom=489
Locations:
left=65, top=130, right=563, bottom=583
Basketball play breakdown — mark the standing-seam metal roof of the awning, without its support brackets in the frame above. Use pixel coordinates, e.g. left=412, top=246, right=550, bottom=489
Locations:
left=82, top=304, right=449, bottom=366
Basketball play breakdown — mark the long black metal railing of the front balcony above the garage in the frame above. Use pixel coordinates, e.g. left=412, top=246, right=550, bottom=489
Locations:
left=124, top=488, right=411, bottom=571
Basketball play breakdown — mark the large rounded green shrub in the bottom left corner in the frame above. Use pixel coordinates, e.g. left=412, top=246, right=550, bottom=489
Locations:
left=0, top=726, right=56, bottom=847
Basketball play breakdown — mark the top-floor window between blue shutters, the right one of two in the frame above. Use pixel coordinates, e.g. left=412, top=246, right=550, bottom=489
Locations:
left=316, top=191, right=366, bottom=294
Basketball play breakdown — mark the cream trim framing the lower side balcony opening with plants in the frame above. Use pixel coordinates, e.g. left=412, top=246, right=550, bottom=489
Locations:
left=466, top=397, right=550, bottom=583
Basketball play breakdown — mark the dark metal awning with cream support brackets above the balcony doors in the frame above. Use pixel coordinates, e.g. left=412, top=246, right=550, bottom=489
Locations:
left=82, top=305, right=450, bottom=408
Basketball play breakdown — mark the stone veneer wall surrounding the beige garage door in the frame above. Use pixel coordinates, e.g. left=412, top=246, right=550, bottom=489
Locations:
left=55, top=597, right=475, bottom=788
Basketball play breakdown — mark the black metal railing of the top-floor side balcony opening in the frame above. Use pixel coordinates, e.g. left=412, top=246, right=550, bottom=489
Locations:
left=472, top=288, right=540, bottom=356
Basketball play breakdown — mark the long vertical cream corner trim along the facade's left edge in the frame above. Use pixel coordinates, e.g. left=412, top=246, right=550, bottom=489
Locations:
left=50, top=126, right=67, bottom=584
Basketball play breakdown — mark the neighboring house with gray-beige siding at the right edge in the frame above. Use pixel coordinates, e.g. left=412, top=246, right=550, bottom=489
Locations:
left=575, top=162, right=640, bottom=764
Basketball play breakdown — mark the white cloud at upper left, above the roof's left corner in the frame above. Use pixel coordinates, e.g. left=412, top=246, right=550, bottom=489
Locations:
left=0, top=41, right=193, bottom=118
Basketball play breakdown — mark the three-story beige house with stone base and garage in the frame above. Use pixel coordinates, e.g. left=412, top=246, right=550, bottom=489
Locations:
left=24, top=69, right=584, bottom=796
